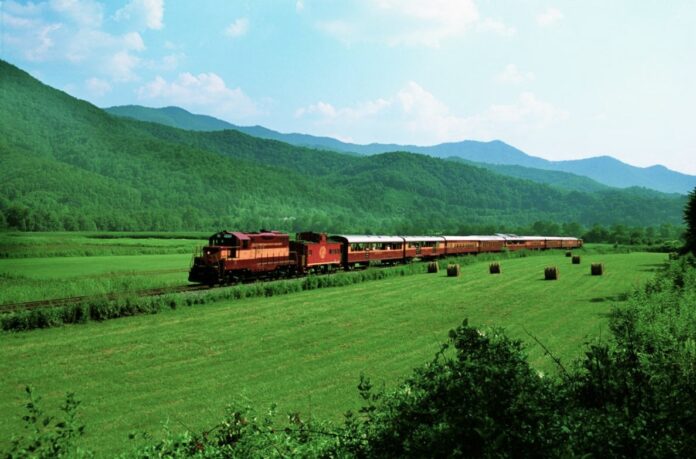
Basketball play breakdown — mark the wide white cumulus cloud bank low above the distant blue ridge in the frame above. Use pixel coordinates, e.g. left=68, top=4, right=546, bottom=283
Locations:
left=295, top=81, right=569, bottom=144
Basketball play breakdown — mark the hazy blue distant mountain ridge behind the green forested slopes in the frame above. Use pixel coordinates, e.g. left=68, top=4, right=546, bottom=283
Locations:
left=106, top=105, right=696, bottom=194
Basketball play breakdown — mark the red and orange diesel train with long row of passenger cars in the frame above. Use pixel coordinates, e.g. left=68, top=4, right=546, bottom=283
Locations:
left=188, top=230, right=582, bottom=285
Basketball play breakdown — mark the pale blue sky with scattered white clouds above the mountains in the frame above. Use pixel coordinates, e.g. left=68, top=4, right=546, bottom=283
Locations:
left=0, top=0, right=696, bottom=174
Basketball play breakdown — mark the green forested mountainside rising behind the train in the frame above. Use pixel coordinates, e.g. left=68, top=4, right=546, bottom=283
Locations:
left=0, top=61, right=685, bottom=233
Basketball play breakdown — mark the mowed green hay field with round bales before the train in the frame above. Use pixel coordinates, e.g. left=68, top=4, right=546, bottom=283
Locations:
left=0, top=252, right=666, bottom=456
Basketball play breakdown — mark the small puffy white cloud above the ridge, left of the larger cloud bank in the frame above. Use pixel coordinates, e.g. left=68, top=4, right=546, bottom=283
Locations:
left=138, top=73, right=260, bottom=121
